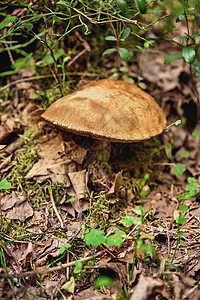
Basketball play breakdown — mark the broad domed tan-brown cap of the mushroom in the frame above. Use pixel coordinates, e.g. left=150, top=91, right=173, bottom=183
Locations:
left=42, top=79, right=166, bottom=143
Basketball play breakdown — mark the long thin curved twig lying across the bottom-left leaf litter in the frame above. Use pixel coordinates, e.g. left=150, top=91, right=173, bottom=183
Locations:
left=0, top=250, right=105, bottom=278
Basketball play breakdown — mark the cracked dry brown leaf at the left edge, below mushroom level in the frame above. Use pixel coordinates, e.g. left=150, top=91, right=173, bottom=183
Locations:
left=2, top=192, right=33, bottom=222
